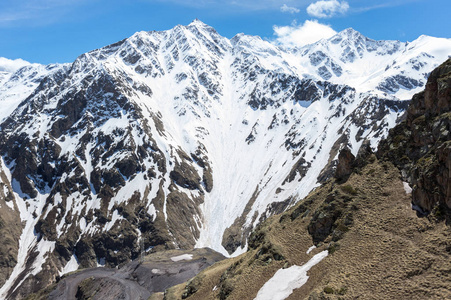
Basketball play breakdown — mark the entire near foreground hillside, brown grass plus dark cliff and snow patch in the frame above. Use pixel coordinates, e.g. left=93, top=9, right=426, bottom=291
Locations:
left=164, top=60, right=451, bottom=300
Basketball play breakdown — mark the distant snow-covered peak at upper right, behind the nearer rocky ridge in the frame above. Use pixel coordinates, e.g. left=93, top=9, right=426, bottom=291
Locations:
left=280, top=28, right=451, bottom=100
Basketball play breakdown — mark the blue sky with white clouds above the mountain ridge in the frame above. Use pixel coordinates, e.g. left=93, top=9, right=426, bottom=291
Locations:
left=0, top=0, right=451, bottom=64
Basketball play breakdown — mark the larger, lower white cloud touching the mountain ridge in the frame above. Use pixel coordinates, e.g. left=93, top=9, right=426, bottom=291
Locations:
left=273, top=20, right=337, bottom=47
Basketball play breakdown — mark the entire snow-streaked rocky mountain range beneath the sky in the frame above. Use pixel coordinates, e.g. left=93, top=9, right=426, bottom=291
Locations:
left=0, top=20, right=451, bottom=298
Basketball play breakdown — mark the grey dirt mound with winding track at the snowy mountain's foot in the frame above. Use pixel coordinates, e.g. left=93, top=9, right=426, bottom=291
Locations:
left=49, top=248, right=224, bottom=300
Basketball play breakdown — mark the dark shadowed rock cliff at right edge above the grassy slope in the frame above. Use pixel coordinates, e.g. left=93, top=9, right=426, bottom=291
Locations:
left=378, top=59, right=451, bottom=218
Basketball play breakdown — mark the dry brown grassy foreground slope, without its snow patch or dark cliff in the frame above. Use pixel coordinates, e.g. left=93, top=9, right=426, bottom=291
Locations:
left=165, top=156, right=451, bottom=300
